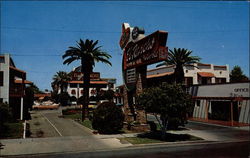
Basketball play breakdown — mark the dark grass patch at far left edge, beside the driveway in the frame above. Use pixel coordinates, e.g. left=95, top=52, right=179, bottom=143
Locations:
left=0, top=122, right=23, bottom=138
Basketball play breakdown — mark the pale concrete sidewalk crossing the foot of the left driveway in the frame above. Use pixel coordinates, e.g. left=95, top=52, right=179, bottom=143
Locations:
left=1, top=136, right=132, bottom=156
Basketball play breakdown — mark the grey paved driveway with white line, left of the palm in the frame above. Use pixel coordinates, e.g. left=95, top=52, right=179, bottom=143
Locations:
left=29, top=109, right=92, bottom=138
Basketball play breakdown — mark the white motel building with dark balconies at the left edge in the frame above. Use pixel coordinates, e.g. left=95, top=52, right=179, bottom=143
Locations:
left=0, top=54, right=32, bottom=120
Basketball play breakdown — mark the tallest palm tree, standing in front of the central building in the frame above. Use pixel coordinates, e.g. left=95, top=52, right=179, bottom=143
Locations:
left=62, top=39, right=112, bottom=121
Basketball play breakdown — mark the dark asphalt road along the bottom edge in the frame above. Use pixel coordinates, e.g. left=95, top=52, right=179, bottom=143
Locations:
left=7, top=141, right=250, bottom=158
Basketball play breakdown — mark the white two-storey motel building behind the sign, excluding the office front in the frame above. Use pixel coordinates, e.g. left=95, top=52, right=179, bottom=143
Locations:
left=115, top=63, right=229, bottom=105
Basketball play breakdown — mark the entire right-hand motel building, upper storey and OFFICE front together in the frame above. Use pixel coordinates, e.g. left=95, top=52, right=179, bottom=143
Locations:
left=115, top=63, right=250, bottom=126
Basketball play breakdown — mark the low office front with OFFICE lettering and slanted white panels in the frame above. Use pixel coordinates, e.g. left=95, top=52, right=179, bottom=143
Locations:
left=190, top=82, right=250, bottom=126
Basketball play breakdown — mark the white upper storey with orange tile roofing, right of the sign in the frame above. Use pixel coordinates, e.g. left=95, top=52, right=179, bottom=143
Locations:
left=147, top=63, right=230, bottom=85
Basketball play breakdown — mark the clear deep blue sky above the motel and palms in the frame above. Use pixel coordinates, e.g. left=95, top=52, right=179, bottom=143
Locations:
left=0, top=1, right=249, bottom=90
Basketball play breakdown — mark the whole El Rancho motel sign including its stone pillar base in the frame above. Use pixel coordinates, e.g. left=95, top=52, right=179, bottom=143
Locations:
left=120, top=23, right=168, bottom=129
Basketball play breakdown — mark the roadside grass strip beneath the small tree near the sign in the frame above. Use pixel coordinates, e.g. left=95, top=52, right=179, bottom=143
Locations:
left=119, top=131, right=202, bottom=144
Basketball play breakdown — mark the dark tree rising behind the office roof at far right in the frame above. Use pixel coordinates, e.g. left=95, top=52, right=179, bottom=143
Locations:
left=230, top=65, right=248, bottom=82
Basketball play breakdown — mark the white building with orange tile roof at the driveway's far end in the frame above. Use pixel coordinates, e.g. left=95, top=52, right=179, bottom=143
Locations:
left=58, top=67, right=116, bottom=100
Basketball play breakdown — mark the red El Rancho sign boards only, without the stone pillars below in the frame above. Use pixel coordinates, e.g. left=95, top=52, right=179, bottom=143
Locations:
left=120, top=23, right=168, bottom=91
